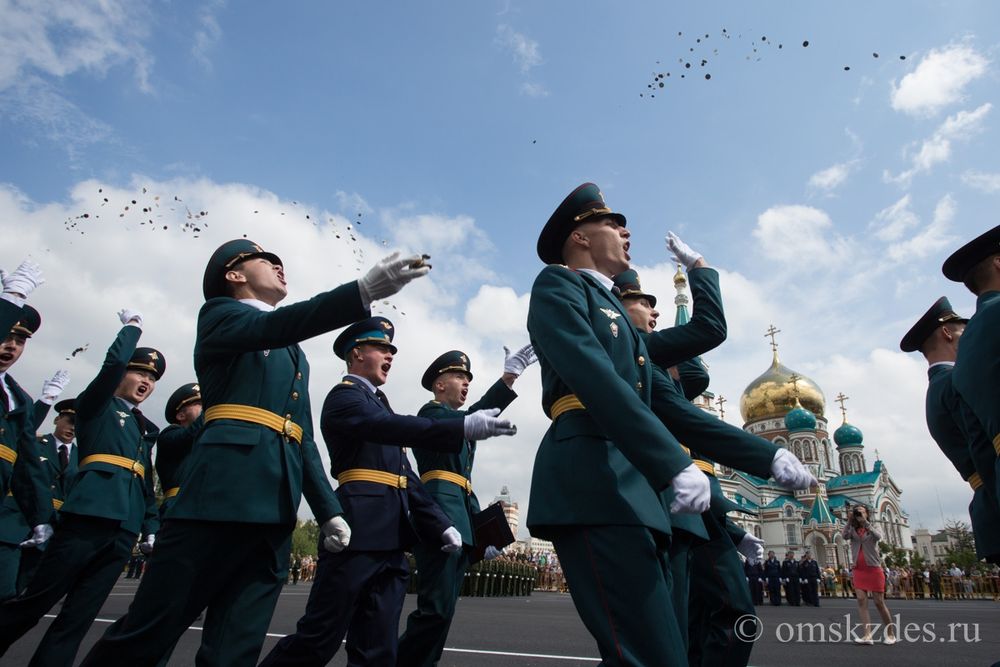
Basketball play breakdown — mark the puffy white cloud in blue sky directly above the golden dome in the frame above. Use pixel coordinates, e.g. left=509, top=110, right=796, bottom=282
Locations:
left=753, top=205, right=850, bottom=267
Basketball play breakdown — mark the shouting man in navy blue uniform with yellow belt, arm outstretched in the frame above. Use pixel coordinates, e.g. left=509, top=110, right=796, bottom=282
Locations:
left=261, top=317, right=513, bottom=667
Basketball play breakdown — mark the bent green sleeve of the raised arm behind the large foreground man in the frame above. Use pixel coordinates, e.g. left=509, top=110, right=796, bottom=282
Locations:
left=647, top=267, right=726, bottom=368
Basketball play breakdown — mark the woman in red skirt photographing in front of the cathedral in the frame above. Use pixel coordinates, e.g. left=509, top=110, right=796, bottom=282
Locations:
left=843, top=505, right=896, bottom=644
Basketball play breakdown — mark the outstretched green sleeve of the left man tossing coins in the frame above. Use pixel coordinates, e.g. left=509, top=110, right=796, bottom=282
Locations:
left=198, top=281, right=370, bottom=356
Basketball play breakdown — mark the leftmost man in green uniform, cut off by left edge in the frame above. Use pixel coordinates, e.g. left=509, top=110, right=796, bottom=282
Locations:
left=0, top=294, right=53, bottom=600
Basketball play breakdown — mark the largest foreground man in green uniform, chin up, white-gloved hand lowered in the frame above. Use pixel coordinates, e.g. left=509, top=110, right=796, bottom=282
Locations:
left=527, top=183, right=709, bottom=665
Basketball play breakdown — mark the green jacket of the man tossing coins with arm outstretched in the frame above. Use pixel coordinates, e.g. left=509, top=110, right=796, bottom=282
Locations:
left=165, top=290, right=368, bottom=525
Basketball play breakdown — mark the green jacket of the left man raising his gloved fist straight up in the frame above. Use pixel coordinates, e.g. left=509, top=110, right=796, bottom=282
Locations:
left=60, top=326, right=160, bottom=535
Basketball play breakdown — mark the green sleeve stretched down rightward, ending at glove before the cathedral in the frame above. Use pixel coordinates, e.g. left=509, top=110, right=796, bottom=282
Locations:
left=653, top=368, right=778, bottom=479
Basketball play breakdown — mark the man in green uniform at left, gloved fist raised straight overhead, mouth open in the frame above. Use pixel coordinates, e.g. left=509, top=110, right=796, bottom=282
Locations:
left=0, top=309, right=166, bottom=665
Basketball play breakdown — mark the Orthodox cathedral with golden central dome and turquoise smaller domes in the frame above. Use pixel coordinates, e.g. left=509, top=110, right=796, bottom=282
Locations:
left=674, top=270, right=912, bottom=568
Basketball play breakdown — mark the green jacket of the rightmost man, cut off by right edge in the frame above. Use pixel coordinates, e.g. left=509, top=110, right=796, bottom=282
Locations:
left=952, top=292, right=1000, bottom=506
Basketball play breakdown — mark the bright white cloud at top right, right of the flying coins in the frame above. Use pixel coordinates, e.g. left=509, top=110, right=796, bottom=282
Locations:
left=892, top=45, right=989, bottom=115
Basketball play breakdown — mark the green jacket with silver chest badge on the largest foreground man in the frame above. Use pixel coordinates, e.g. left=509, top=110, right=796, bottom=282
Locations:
left=527, top=265, right=691, bottom=538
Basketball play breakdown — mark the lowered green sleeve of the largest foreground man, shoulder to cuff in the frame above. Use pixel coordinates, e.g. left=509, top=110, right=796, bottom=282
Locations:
left=528, top=267, right=691, bottom=491
